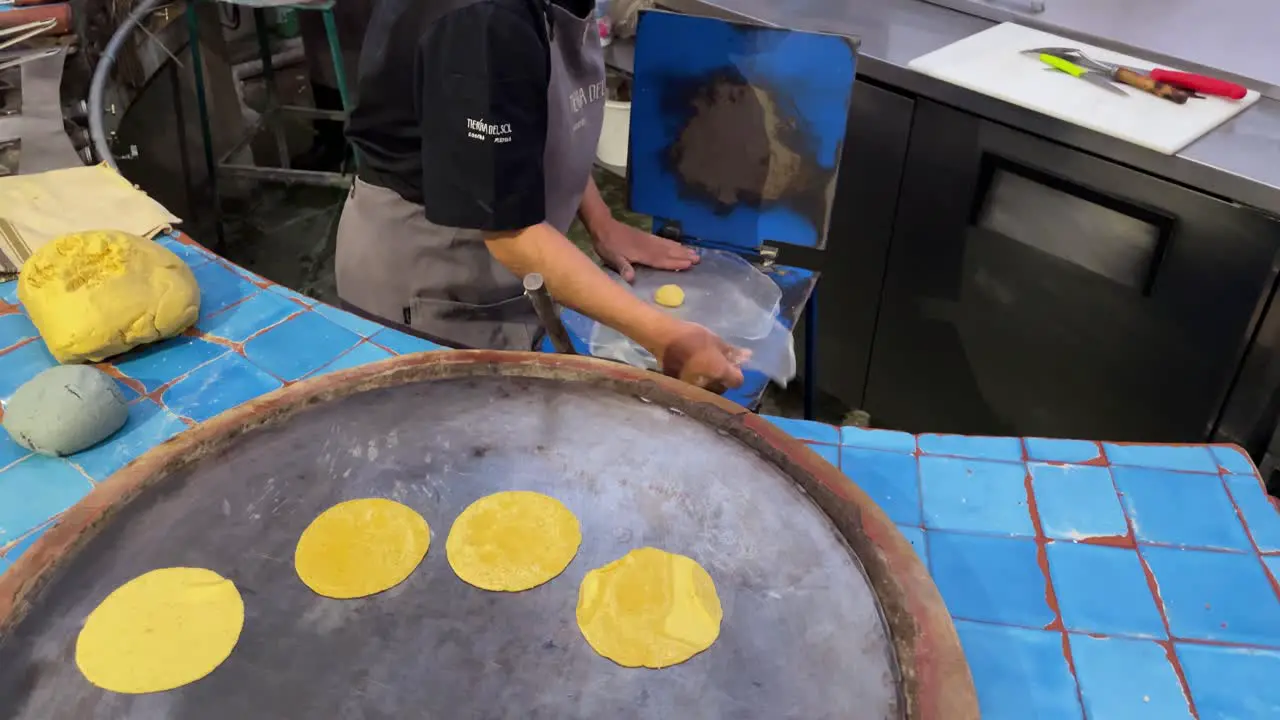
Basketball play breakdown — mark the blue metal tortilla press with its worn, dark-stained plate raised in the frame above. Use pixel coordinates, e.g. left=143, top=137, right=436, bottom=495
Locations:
left=541, top=10, right=858, bottom=416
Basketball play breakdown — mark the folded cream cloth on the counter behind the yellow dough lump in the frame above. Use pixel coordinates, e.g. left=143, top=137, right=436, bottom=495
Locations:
left=0, top=165, right=182, bottom=279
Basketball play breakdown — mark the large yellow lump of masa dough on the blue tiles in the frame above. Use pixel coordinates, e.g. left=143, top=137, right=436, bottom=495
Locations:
left=18, top=231, right=200, bottom=363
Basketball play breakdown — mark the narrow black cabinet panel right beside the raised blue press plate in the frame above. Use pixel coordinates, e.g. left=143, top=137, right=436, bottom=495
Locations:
left=782, top=78, right=914, bottom=407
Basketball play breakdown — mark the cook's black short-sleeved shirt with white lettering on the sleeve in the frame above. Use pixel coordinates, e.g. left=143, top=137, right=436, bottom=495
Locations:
left=347, top=0, right=549, bottom=232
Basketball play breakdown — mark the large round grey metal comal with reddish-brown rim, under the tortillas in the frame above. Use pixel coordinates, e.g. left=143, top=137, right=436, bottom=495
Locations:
left=0, top=351, right=978, bottom=720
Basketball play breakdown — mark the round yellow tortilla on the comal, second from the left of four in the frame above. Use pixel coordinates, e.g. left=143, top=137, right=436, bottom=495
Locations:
left=293, top=497, right=431, bottom=600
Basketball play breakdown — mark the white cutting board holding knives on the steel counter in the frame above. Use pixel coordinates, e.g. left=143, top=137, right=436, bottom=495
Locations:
left=908, top=23, right=1260, bottom=155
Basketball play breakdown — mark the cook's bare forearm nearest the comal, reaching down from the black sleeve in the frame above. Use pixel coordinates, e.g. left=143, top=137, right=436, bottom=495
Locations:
left=485, top=223, right=678, bottom=351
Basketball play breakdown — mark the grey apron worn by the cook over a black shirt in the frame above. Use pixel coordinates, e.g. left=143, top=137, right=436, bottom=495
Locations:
left=334, top=0, right=604, bottom=350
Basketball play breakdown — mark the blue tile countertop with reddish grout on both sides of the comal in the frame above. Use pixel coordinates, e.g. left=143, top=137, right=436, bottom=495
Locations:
left=0, top=237, right=1280, bottom=720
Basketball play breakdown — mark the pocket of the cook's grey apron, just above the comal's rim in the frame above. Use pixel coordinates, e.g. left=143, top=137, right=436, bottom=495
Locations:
left=408, top=295, right=540, bottom=351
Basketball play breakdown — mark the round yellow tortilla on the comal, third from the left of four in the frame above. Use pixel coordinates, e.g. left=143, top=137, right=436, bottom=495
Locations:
left=444, top=491, right=582, bottom=592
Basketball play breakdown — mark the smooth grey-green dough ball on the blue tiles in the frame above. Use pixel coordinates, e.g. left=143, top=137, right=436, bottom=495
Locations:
left=4, top=365, right=129, bottom=457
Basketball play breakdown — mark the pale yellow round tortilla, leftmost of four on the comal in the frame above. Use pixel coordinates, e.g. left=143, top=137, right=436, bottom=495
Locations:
left=76, top=568, right=244, bottom=694
